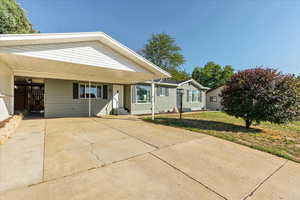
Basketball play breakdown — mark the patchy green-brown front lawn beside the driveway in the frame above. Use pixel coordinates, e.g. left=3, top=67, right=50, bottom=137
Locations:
left=144, top=112, right=300, bottom=162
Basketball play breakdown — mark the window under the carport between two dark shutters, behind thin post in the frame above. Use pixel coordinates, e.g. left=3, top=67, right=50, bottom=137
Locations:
left=79, top=84, right=102, bottom=99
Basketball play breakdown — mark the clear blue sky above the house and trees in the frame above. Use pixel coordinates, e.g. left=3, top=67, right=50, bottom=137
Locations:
left=17, top=0, right=300, bottom=74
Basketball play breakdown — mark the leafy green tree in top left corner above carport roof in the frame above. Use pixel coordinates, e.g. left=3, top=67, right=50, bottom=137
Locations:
left=0, top=0, right=35, bottom=34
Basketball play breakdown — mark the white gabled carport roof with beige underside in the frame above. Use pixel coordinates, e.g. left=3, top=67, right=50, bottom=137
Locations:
left=0, top=32, right=170, bottom=83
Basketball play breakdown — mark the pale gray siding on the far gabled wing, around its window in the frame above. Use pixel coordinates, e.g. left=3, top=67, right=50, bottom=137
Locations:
left=179, top=82, right=206, bottom=111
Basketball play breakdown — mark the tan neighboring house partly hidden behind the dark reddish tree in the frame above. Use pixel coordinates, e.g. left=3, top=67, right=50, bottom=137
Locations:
left=206, top=85, right=225, bottom=111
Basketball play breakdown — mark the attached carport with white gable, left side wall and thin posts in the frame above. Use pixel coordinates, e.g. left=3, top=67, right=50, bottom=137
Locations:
left=0, top=32, right=170, bottom=120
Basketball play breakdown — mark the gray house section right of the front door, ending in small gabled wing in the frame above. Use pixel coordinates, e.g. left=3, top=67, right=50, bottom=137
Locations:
left=124, top=79, right=209, bottom=114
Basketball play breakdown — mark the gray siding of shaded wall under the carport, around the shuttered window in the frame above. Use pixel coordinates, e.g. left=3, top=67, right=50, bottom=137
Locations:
left=45, top=79, right=112, bottom=117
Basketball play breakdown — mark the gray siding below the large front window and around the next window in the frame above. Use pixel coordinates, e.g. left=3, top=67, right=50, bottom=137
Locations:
left=130, top=84, right=176, bottom=115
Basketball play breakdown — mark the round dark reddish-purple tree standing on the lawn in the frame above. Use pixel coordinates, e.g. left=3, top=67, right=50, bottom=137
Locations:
left=221, top=68, right=299, bottom=128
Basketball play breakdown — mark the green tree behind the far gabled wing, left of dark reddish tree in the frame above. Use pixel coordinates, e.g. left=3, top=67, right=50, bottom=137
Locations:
left=192, top=62, right=234, bottom=88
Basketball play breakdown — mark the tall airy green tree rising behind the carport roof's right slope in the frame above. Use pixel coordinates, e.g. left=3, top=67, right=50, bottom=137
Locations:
left=140, top=33, right=188, bottom=80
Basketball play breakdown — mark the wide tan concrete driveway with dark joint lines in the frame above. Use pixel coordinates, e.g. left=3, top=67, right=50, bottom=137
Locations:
left=0, top=118, right=300, bottom=200
